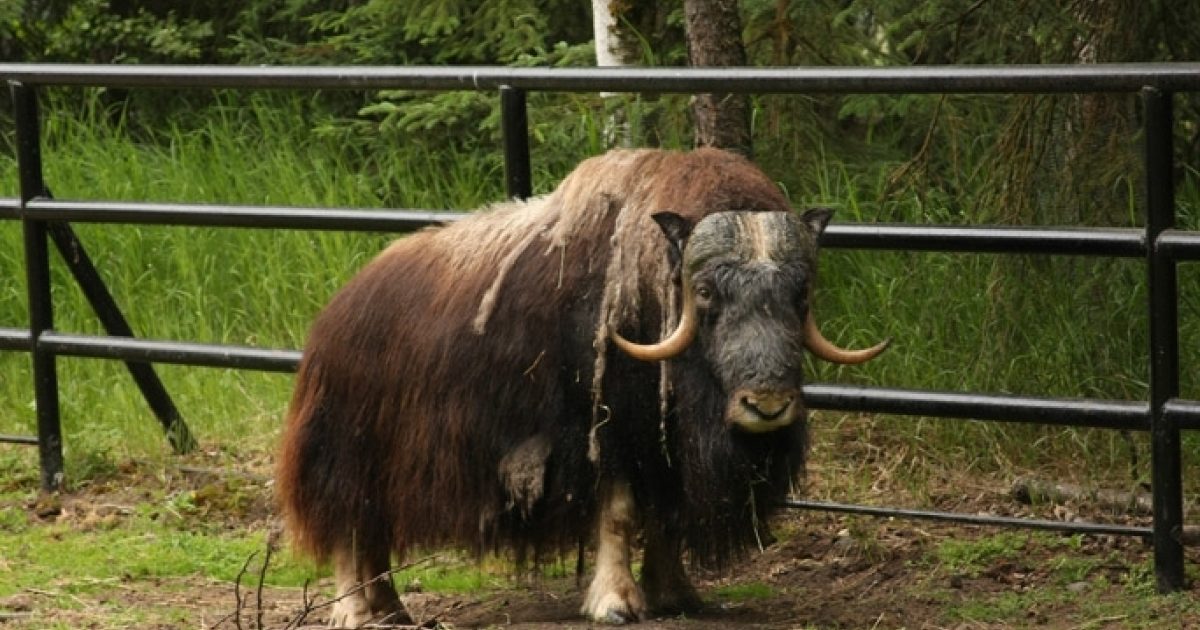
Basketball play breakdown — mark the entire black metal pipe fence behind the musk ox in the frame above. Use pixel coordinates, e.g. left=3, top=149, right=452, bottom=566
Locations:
left=0, top=64, right=1200, bottom=592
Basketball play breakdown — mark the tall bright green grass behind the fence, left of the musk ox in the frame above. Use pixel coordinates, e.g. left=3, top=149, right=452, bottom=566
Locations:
left=0, top=89, right=503, bottom=461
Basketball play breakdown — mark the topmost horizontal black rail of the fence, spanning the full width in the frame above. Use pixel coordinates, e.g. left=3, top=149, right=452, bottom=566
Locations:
left=0, top=64, right=1200, bottom=94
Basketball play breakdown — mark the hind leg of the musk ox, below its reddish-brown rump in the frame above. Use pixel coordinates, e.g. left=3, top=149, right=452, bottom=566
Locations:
left=329, top=537, right=410, bottom=628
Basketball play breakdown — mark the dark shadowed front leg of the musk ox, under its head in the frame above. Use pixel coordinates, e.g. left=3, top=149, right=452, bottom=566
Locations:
left=642, top=523, right=704, bottom=614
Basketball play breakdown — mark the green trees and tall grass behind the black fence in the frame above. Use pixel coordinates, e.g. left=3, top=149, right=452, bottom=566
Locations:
left=0, top=0, right=1200, bottom=492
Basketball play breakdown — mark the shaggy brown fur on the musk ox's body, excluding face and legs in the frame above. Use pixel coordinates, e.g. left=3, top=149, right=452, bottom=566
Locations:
left=276, top=150, right=802, bottom=559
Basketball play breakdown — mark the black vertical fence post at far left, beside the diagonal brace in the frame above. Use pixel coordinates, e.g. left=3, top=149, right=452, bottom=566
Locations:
left=10, top=82, right=62, bottom=492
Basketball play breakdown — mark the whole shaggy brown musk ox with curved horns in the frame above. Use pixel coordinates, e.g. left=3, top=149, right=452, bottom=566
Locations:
left=277, top=149, right=887, bottom=626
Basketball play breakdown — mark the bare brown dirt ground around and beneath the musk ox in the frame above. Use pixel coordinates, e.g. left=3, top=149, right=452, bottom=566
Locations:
left=0, top=420, right=1200, bottom=630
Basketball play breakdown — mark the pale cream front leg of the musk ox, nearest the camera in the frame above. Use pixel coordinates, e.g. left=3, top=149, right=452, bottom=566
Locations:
left=582, top=481, right=646, bottom=624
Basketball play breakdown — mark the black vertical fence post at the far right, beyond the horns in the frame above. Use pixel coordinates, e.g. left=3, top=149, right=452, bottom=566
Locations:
left=1141, top=88, right=1183, bottom=593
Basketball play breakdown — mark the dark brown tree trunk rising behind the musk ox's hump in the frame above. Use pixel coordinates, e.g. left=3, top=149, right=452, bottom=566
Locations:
left=683, top=0, right=754, bottom=156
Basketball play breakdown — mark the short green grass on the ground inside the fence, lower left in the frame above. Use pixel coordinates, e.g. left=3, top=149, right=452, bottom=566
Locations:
left=0, top=441, right=525, bottom=628
